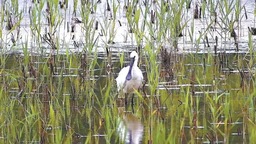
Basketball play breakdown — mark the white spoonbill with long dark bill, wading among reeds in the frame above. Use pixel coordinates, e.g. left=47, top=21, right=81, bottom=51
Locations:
left=116, top=51, right=143, bottom=93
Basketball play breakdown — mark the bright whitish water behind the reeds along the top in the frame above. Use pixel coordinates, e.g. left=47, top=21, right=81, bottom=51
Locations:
left=1, top=0, right=255, bottom=55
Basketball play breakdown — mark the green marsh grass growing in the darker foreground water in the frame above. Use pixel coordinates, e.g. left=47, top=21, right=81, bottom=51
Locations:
left=1, top=48, right=254, bottom=143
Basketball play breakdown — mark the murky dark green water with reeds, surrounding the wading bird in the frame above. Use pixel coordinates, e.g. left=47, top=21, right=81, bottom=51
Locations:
left=0, top=53, right=255, bottom=143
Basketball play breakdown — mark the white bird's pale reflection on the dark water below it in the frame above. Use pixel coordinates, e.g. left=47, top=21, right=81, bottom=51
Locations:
left=117, top=107, right=143, bottom=144
